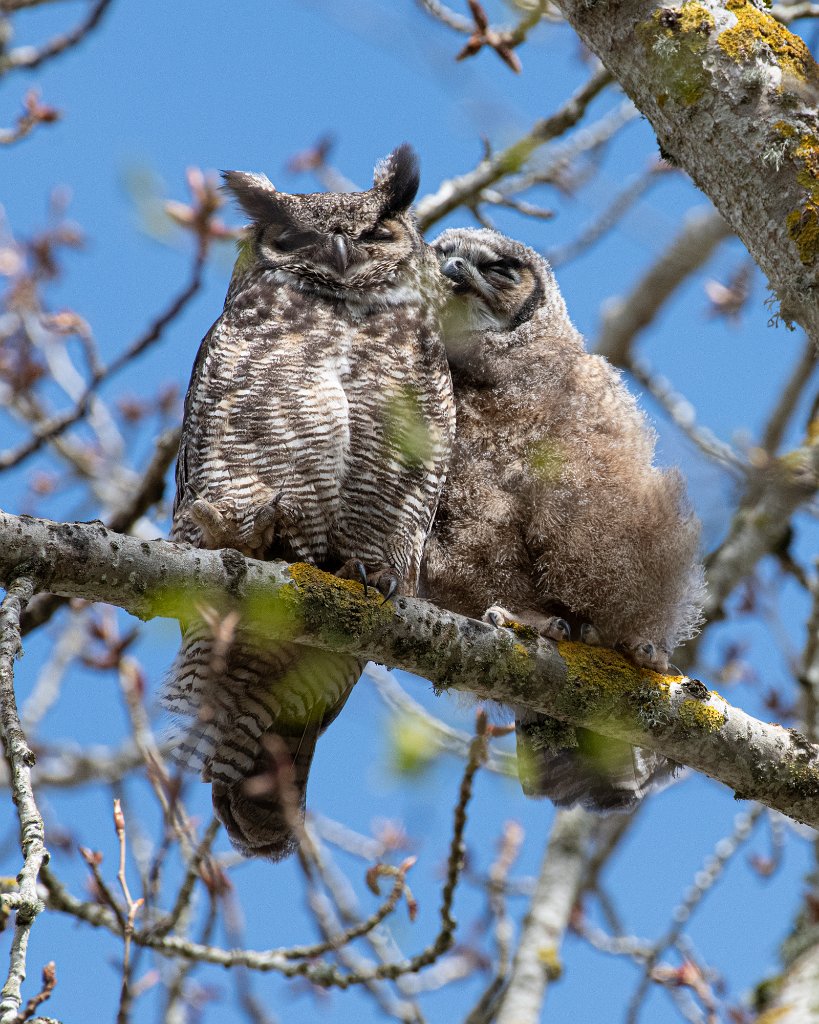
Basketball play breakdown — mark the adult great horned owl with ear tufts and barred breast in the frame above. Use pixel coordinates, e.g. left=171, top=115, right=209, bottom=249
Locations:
left=163, top=145, right=455, bottom=859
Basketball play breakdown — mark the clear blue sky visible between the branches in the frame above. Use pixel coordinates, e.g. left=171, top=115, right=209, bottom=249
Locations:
left=0, top=0, right=819, bottom=1024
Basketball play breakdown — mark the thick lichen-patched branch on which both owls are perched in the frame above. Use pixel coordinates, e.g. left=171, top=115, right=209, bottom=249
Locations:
left=0, top=513, right=819, bottom=826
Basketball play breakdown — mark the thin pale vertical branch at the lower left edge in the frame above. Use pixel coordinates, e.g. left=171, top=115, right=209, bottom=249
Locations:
left=0, top=575, right=48, bottom=1024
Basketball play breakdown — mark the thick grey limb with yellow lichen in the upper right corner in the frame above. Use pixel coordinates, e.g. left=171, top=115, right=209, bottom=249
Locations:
left=558, top=0, right=819, bottom=342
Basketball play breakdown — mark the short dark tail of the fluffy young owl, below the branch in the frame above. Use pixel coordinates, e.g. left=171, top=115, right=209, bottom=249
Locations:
left=515, top=708, right=676, bottom=813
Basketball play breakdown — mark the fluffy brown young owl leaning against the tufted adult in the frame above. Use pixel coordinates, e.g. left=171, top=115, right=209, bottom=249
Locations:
left=424, top=229, right=703, bottom=810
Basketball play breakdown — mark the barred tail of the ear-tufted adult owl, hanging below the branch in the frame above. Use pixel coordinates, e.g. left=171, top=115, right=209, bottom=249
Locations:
left=161, top=623, right=363, bottom=860
